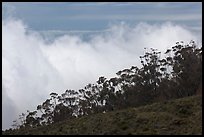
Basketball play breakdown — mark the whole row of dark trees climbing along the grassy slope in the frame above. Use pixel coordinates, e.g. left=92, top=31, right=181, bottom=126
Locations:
left=9, top=41, right=202, bottom=131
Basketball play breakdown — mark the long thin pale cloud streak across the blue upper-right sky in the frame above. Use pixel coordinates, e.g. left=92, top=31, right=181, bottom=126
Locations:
left=59, top=12, right=202, bottom=21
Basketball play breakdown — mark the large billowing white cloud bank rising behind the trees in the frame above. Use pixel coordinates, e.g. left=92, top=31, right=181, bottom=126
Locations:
left=2, top=18, right=200, bottom=129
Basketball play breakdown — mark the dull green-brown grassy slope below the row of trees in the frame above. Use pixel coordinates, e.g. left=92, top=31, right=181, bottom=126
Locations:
left=3, top=96, right=202, bottom=135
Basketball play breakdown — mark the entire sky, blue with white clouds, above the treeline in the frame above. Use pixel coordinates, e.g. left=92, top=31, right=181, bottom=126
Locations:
left=2, top=2, right=202, bottom=129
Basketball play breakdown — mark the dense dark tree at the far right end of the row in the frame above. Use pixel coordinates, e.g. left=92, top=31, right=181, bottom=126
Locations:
left=173, top=41, right=202, bottom=97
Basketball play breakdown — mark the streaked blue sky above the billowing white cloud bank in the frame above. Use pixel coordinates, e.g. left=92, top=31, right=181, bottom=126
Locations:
left=3, top=2, right=202, bottom=30
